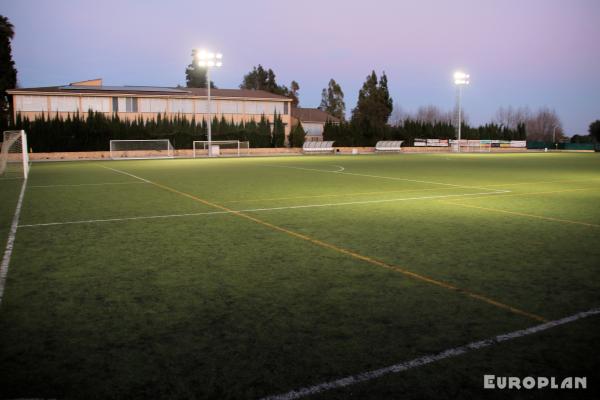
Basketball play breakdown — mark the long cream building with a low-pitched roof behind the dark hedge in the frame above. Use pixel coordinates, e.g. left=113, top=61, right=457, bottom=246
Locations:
left=7, top=79, right=291, bottom=136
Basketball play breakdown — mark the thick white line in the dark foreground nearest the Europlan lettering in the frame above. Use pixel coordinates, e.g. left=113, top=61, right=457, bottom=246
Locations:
left=261, top=308, right=600, bottom=400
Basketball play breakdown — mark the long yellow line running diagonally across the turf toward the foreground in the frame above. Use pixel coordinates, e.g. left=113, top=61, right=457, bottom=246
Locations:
left=144, top=179, right=547, bottom=322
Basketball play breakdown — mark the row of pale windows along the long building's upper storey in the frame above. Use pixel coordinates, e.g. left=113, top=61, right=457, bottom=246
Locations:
left=15, top=95, right=288, bottom=115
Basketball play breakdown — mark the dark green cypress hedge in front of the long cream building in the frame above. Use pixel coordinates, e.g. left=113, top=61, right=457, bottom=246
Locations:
left=8, top=111, right=290, bottom=153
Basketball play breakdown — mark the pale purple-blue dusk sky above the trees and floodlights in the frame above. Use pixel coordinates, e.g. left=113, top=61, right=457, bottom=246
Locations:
left=0, top=0, right=600, bottom=135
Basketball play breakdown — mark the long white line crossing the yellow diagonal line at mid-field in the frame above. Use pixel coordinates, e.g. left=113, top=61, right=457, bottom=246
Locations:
left=19, top=190, right=510, bottom=228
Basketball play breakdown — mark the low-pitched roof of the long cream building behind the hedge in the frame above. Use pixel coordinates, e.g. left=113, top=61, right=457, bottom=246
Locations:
left=7, top=82, right=291, bottom=101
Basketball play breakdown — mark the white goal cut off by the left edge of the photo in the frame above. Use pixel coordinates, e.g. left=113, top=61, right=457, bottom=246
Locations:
left=0, top=130, right=29, bottom=179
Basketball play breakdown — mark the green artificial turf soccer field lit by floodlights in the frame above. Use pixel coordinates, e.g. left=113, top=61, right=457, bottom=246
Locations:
left=0, top=153, right=600, bottom=399
